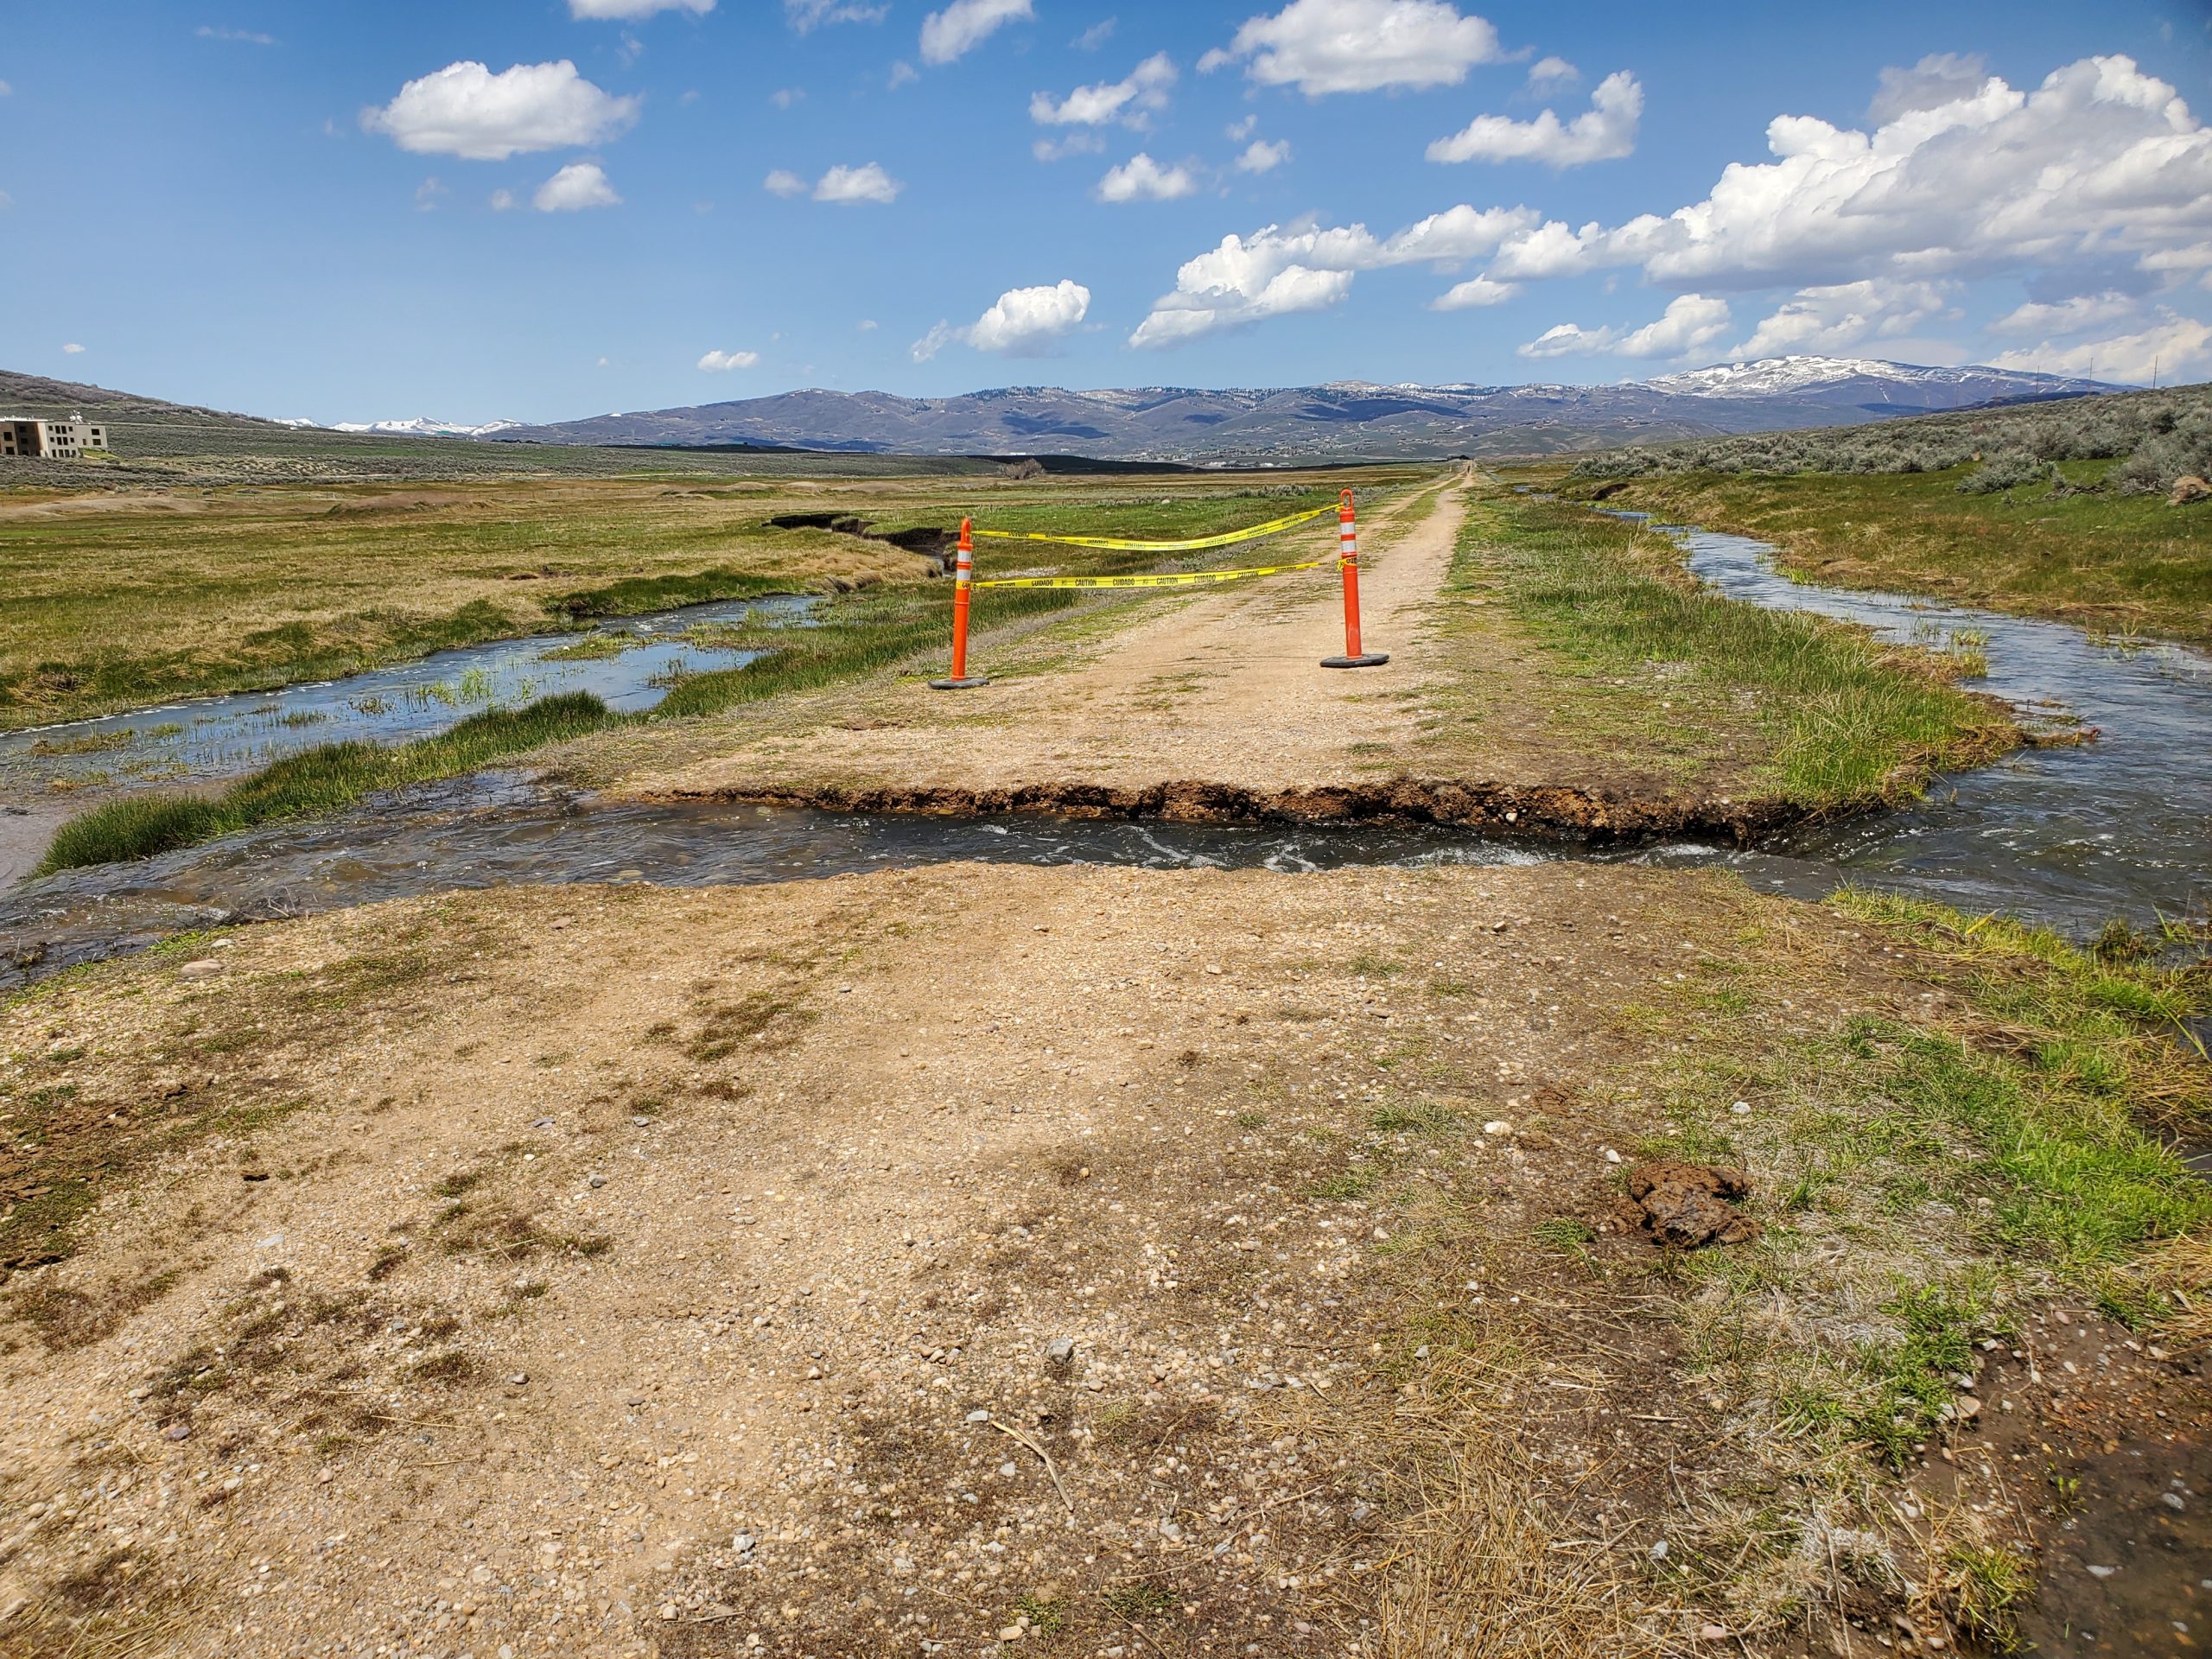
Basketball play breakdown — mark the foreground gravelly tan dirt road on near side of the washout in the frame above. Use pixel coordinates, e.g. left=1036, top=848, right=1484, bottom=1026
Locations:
left=0, top=865, right=2201, bottom=1659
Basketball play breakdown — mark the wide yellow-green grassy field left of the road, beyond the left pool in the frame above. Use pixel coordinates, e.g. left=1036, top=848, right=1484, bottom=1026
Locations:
left=0, top=462, right=1370, bottom=726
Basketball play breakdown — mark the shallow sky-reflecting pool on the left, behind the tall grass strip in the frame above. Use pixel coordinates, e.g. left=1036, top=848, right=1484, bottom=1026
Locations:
left=0, top=595, right=818, bottom=805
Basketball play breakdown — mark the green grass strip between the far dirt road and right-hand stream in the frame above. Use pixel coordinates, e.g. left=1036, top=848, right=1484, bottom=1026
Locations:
left=1453, top=495, right=2015, bottom=807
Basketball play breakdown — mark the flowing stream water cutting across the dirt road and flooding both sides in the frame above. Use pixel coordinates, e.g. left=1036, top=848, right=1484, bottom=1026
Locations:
left=0, top=529, right=2212, bottom=987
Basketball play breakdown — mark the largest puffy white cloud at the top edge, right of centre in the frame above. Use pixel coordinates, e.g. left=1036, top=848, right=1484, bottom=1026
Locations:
left=1199, top=0, right=1504, bottom=98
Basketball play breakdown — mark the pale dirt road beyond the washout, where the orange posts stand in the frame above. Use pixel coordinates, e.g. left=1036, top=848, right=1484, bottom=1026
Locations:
left=617, top=486, right=1637, bottom=817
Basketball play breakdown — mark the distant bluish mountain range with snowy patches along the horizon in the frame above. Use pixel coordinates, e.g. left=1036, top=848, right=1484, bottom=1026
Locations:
left=0, top=356, right=2126, bottom=465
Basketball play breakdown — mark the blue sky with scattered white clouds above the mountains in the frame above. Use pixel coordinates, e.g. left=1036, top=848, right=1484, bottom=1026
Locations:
left=0, top=0, right=2212, bottom=420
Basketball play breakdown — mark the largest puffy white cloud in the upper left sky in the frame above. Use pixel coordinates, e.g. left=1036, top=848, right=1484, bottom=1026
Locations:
left=360, top=58, right=637, bottom=162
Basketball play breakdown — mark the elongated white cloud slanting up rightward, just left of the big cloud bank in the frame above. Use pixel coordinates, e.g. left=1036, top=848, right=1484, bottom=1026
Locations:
left=1128, top=204, right=1535, bottom=347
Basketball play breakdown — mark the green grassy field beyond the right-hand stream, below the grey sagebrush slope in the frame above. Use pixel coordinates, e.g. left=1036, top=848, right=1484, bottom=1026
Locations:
left=1516, top=460, right=2212, bottom=644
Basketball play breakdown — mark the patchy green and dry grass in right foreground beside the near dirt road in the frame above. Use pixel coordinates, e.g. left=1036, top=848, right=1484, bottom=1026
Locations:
left=1639, top=892, right=2212, bottom=1466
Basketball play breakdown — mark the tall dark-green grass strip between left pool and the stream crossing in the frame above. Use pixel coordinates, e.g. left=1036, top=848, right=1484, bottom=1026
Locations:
left=38, top=692, right=617, bottom=874
